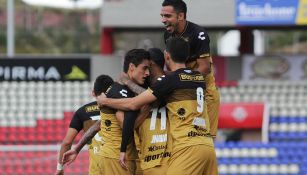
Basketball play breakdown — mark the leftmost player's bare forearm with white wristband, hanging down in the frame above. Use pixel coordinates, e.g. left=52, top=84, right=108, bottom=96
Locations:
left=55, top=128, right=78, bottom=175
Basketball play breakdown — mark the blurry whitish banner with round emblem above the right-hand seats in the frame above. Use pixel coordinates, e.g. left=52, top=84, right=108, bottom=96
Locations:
left=242, top=55, right=307, bottom=80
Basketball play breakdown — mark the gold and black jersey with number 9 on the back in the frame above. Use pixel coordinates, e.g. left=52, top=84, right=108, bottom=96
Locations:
left=151, top=68, right=213, bottom=152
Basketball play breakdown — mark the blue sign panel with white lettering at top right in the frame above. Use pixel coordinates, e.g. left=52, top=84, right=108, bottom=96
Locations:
left=236, top=0, right=299, bottom=25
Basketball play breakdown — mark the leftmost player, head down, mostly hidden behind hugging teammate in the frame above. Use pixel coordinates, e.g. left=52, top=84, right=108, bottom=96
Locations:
left=55, top=75, right=113, bottom=175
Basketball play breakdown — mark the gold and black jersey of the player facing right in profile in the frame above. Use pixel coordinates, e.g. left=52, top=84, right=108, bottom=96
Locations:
left=100, top=83, right=137, bottom=160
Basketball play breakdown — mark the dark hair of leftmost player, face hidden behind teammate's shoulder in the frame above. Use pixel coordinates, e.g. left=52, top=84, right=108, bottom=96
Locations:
left=93, top=75, right=114, bottom=96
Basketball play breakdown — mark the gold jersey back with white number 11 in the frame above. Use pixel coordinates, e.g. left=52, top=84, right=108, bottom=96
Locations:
left=135, top=106, right=172, bottom=170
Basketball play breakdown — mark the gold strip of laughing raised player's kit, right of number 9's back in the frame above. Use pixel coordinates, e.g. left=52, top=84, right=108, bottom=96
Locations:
left=205, top=86, right=221, bottom=138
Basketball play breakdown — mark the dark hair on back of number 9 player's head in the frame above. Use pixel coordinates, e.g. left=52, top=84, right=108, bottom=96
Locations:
left=165, top=37, right=190, bottom=63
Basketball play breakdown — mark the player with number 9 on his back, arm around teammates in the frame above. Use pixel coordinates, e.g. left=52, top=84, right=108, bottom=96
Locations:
left=97, top=37, right=218, bottom=175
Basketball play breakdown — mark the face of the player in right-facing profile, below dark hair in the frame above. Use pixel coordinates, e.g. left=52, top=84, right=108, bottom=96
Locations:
left=129, top=59, right=150, bottom=85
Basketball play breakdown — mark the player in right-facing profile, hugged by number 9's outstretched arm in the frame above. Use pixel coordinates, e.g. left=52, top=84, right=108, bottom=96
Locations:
left=63, top=49, right=150, bottom=175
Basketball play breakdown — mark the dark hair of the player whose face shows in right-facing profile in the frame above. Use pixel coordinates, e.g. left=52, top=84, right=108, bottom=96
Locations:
left=124, top=49, right=150, bottom=73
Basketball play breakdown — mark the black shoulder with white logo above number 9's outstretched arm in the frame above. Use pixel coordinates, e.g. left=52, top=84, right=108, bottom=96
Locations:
left=106, top=82, right=134, bottom=98
